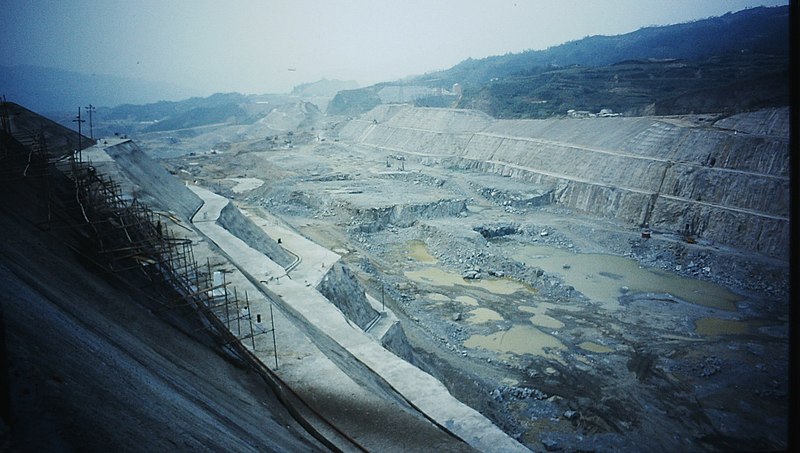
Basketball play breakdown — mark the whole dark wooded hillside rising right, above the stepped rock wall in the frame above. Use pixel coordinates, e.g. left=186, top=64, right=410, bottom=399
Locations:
left=329, top=7, right=789, bottom=118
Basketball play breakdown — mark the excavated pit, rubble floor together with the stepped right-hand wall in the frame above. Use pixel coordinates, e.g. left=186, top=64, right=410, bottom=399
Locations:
left=153, top=106, right=789, bottom=451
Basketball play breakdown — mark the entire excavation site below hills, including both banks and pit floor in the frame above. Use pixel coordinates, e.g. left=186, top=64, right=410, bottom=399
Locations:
left=0, top=102, right=791, bottom=452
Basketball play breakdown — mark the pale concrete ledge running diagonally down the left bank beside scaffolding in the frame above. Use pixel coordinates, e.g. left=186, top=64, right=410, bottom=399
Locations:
left=186, top=187, right=527, bottom=451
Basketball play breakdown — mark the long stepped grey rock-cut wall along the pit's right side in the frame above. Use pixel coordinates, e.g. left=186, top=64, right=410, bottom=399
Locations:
left=339, top=106, right=790, bottom=260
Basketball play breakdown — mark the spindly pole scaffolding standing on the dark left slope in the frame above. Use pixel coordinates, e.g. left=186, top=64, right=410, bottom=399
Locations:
left=0, top=117, right=278, bottom=368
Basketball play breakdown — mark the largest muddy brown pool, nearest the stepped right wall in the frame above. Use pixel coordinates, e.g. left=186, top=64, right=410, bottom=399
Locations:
left=510, top=245, right=741, bottom=311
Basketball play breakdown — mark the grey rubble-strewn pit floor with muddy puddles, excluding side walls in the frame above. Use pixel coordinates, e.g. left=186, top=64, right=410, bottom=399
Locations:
left=153, top=130, right=789, bottom=451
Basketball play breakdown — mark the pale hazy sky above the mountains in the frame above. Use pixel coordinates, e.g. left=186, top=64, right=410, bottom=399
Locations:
left=0, top=0, right=788, bottom=94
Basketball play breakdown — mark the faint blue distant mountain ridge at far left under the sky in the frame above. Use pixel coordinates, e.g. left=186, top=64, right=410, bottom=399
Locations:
left=0, top=65, right=198, bottom=112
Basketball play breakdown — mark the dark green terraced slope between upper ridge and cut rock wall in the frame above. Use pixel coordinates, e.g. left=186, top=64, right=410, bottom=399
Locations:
left=458, top=54, right=789, bottom=118
